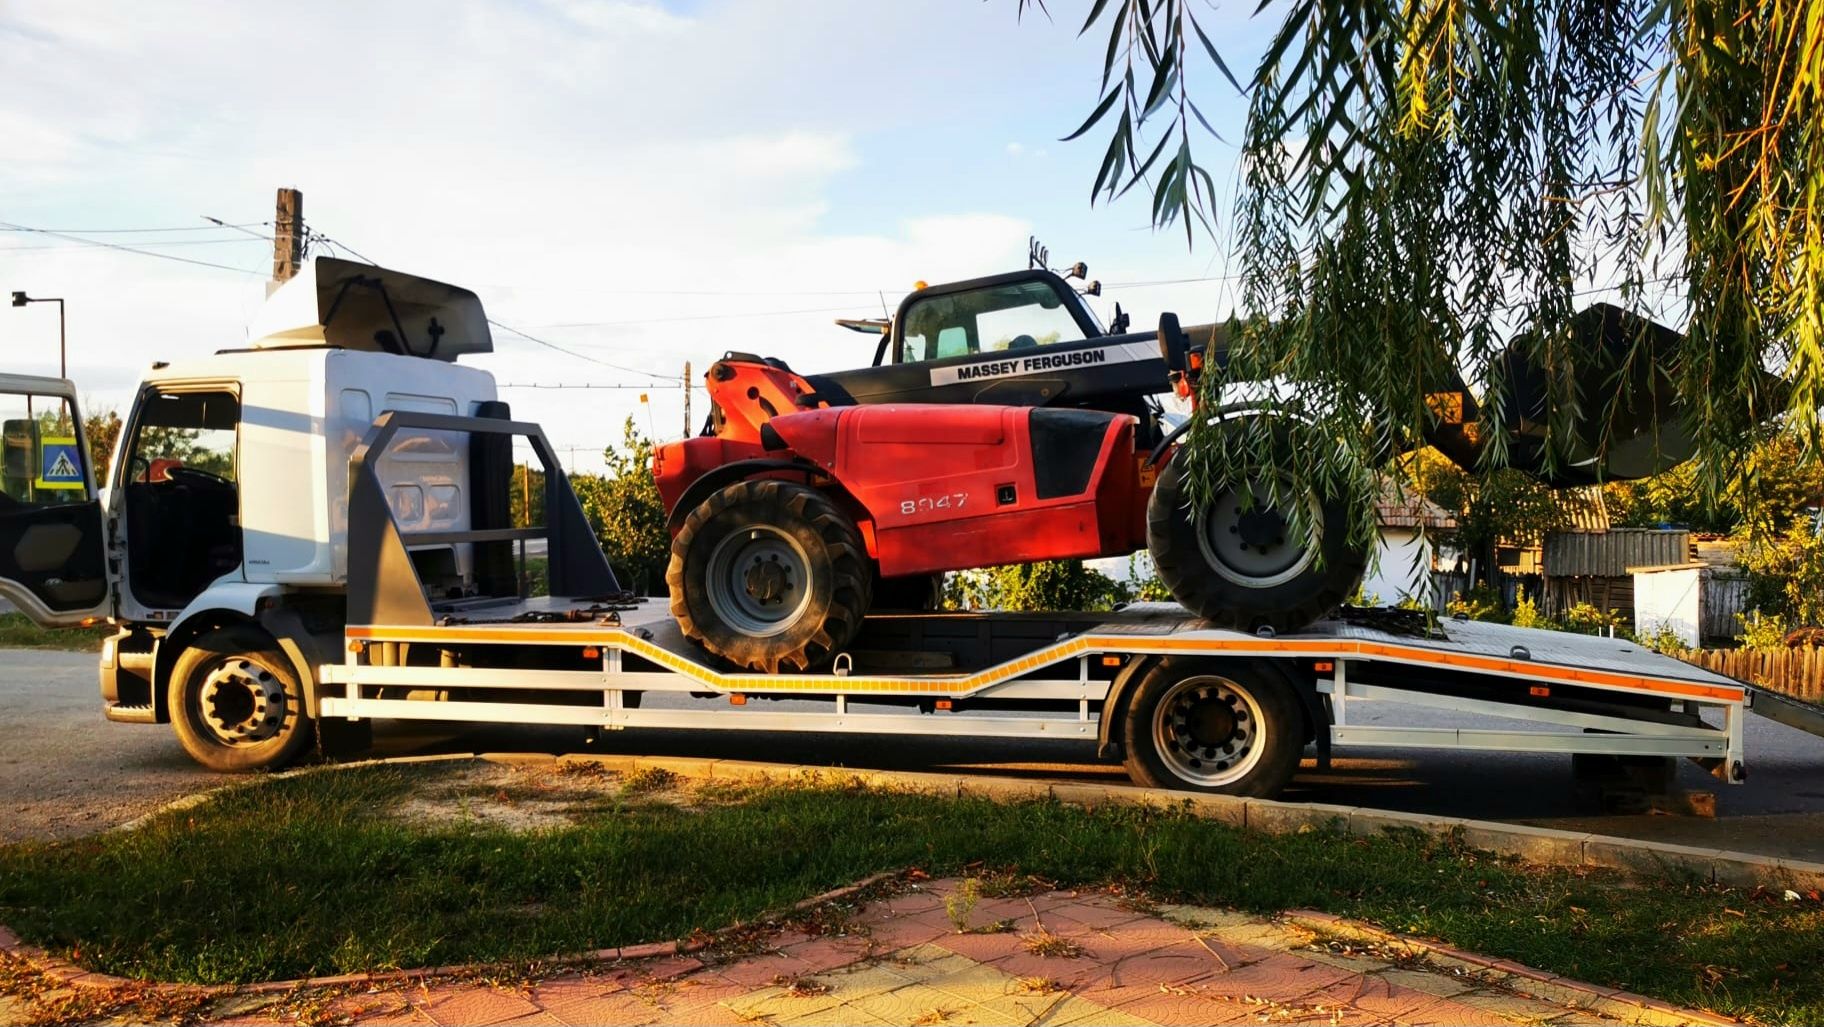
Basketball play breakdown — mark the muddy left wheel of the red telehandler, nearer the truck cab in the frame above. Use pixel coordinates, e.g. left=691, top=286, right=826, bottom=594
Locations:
left=666, top=478, right=872, bottom=673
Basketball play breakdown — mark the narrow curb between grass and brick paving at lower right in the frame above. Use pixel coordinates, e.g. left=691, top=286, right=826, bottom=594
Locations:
left=1280, top=910, right=1740, bottom=1027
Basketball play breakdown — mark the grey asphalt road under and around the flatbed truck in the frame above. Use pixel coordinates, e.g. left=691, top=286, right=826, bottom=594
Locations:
left=0, top=649, right=1824, bottom=861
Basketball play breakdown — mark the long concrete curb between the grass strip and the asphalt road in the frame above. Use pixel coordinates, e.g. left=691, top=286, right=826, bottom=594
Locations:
left=539, top=753, right=1824, bottom=894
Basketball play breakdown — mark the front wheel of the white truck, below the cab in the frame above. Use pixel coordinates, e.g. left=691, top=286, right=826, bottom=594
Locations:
left=170, top=628, right=310, bottom=773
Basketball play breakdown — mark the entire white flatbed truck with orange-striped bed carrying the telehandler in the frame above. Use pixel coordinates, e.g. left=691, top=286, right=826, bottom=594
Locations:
left=0, top=259, right=1751, bottom=795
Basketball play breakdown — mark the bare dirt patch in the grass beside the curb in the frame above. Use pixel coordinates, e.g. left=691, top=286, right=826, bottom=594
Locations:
left=389, top=761, right=699, bottom=832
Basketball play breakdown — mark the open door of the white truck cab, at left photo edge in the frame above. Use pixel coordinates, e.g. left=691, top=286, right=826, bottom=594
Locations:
left=0, top=374, right=109, bottom=628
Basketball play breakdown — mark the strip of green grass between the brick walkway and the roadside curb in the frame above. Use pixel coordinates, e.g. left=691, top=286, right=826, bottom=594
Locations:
left=0, top=768, right=1824, bottom=1023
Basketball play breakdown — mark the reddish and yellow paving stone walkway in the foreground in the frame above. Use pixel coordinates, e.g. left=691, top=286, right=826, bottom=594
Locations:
left=153, top=881, right=1718, bottom=1027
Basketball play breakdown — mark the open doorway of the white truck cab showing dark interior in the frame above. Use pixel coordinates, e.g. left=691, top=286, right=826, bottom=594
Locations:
left=120, top=390, right=241, bottom=607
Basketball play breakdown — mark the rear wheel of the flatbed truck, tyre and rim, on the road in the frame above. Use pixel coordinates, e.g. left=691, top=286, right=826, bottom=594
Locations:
left=1122, top=659, right=1304, bottom=799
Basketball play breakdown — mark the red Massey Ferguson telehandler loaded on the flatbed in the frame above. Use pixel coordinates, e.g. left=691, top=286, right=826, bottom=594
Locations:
left=653, top=265, right=1689, bottom=673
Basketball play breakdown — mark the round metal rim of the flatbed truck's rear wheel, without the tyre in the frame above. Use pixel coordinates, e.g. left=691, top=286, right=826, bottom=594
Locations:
left=1153, top=675, right=1266, bottom=788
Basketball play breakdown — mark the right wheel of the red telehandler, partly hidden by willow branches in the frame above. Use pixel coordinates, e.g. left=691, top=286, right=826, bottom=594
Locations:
left=1145, top=441, right=1368, bottom=631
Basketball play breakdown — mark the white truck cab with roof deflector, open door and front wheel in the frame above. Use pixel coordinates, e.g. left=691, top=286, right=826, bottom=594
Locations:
left=0, top=257, right=511, bottom=770
